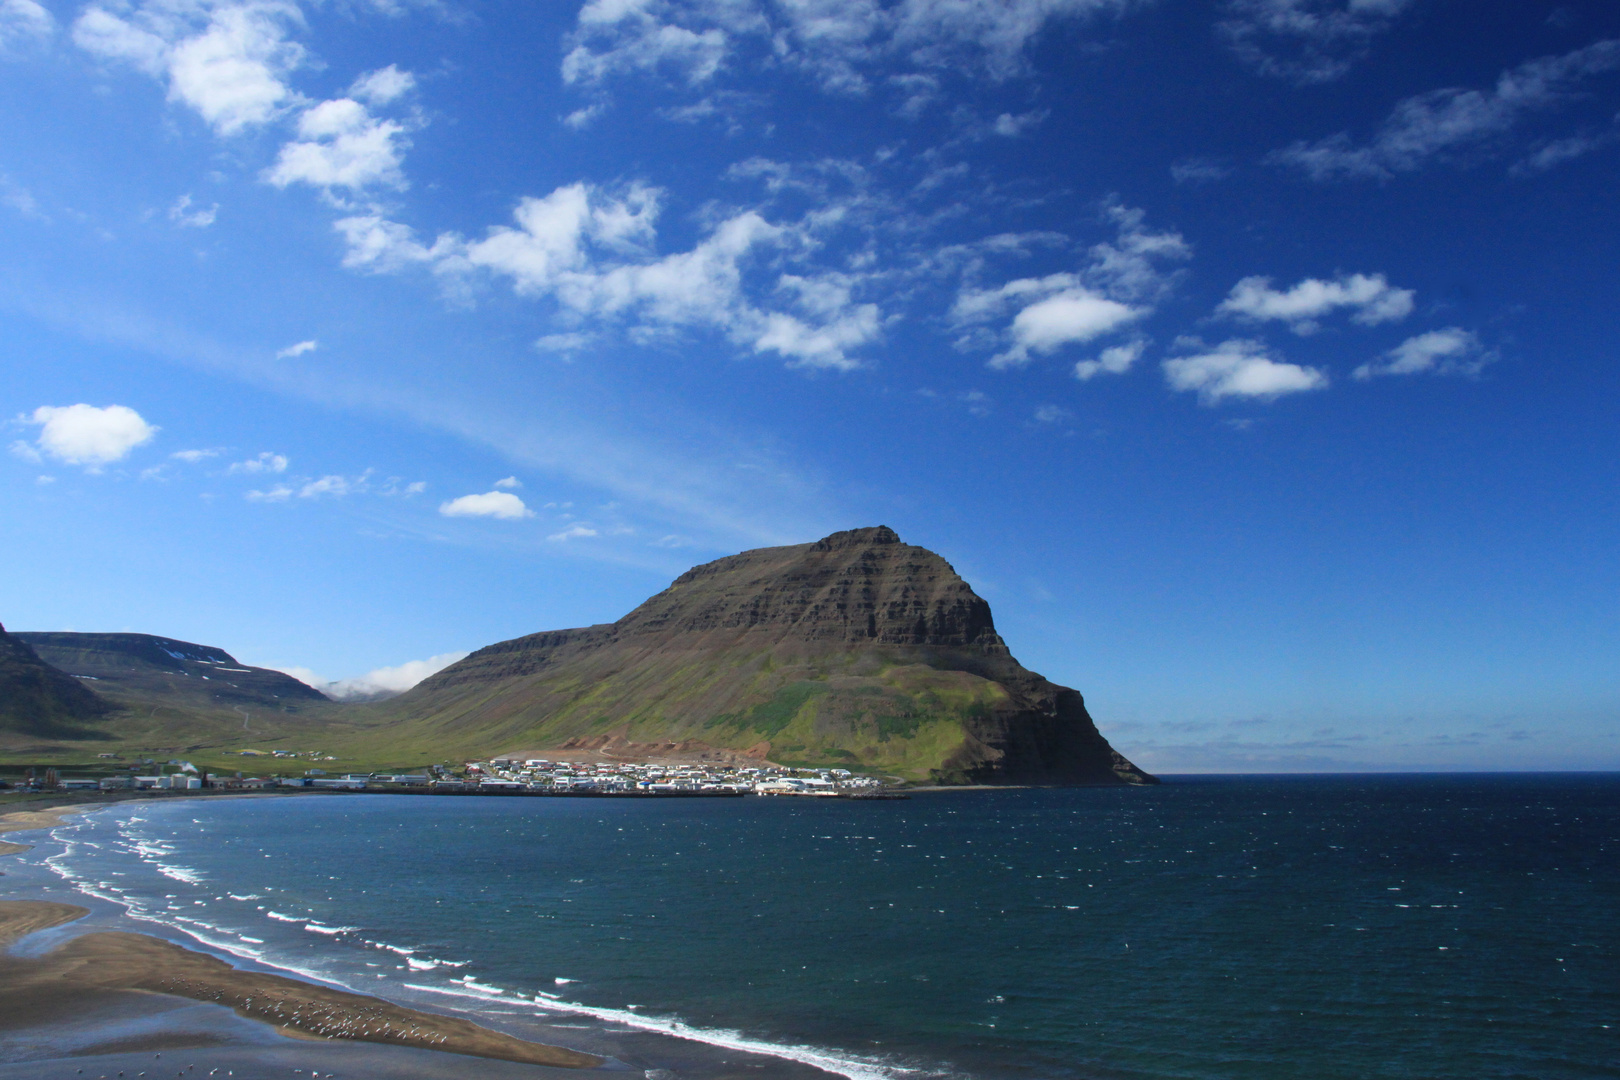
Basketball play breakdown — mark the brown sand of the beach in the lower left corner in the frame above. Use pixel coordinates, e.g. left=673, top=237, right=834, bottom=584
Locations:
left=0, top=805, right=606, bottom=1075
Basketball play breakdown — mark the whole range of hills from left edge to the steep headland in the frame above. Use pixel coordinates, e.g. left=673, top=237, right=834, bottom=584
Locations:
left=0, top=526, right=1155, bottom=784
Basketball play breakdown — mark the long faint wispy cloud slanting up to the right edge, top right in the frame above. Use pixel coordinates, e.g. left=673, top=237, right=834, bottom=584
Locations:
left=1267, top=39, right=1620, bottom=180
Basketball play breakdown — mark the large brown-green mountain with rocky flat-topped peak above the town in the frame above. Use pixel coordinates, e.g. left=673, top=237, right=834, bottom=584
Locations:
left=366, top=526, right=1153, bottom=784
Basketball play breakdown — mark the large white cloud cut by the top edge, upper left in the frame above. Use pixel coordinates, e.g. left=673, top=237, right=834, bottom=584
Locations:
left=73, top=0, right=305, bottom=134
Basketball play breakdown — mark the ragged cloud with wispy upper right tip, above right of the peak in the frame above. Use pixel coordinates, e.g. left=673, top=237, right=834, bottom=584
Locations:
left=951, top=204, right=1191, bottom=369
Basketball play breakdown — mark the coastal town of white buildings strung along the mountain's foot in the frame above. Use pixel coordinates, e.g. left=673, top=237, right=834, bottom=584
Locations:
left=0, top=750, right=904, bottom=798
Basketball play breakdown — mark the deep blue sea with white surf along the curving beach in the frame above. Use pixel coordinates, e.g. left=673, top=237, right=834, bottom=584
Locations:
left=23, top=774, right=1620, bottom=1080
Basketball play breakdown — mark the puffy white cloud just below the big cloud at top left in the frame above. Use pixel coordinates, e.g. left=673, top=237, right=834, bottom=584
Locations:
left=264, top=97, right=410, bottom=191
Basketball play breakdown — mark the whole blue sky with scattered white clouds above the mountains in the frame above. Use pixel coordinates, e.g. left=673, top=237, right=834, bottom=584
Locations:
left=0, top=0, right=1620, bottom=772
